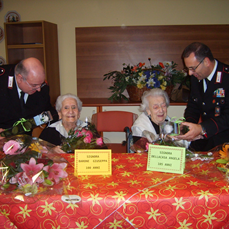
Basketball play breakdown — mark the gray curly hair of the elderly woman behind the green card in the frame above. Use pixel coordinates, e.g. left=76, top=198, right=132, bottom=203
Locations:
left=139, top=88, right=170, bottom=112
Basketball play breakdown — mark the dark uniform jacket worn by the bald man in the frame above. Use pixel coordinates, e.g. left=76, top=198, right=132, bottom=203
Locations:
left=0, top=65, right=58, bottom=129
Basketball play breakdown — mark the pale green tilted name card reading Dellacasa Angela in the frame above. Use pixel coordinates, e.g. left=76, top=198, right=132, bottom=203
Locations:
left=147, top=145, right=185, bottom=174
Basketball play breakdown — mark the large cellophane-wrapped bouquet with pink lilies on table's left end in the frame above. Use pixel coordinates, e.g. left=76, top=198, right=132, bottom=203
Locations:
left=0, top=135, right=77, bottom=196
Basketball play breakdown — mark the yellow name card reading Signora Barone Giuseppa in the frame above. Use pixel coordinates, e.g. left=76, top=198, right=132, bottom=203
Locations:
left=74, top=149, right=112, bottom=176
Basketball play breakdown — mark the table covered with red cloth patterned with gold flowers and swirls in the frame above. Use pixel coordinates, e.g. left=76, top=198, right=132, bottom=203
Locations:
left=0, top=153, right=229, bottom=229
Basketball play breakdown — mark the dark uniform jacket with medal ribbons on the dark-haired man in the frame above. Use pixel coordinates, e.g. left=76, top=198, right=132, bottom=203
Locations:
left=185, top=61, right=229, bottom=151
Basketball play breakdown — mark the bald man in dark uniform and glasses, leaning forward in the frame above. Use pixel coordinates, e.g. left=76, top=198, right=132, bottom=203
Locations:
left=0, top=57, right=58, bottom=132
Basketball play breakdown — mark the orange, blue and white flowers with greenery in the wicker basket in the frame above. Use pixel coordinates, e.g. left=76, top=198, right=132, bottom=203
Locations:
left=103, top=58, right=187, bottom=101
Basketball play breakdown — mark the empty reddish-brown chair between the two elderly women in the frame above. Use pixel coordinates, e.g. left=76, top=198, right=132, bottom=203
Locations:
left=91, top=111, right=138, bottom=153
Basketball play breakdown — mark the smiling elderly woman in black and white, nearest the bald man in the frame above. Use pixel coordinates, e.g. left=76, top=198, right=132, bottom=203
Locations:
left=40, top=94, right=87, bottom=153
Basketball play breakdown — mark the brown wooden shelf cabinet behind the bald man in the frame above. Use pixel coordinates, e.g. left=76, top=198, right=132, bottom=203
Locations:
left=4, top=21, right=60, bottom=104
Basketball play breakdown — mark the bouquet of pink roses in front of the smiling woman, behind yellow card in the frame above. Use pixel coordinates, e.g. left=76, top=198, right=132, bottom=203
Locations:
left=61, top=124, right=106, bottom=153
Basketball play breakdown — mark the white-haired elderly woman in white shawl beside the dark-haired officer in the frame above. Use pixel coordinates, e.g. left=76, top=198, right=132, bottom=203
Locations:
left=131, top=88, right=169, bottom=142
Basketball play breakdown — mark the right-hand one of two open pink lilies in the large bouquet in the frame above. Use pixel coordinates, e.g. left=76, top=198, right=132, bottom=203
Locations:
left=44, top=163, right=68, bottom=184
